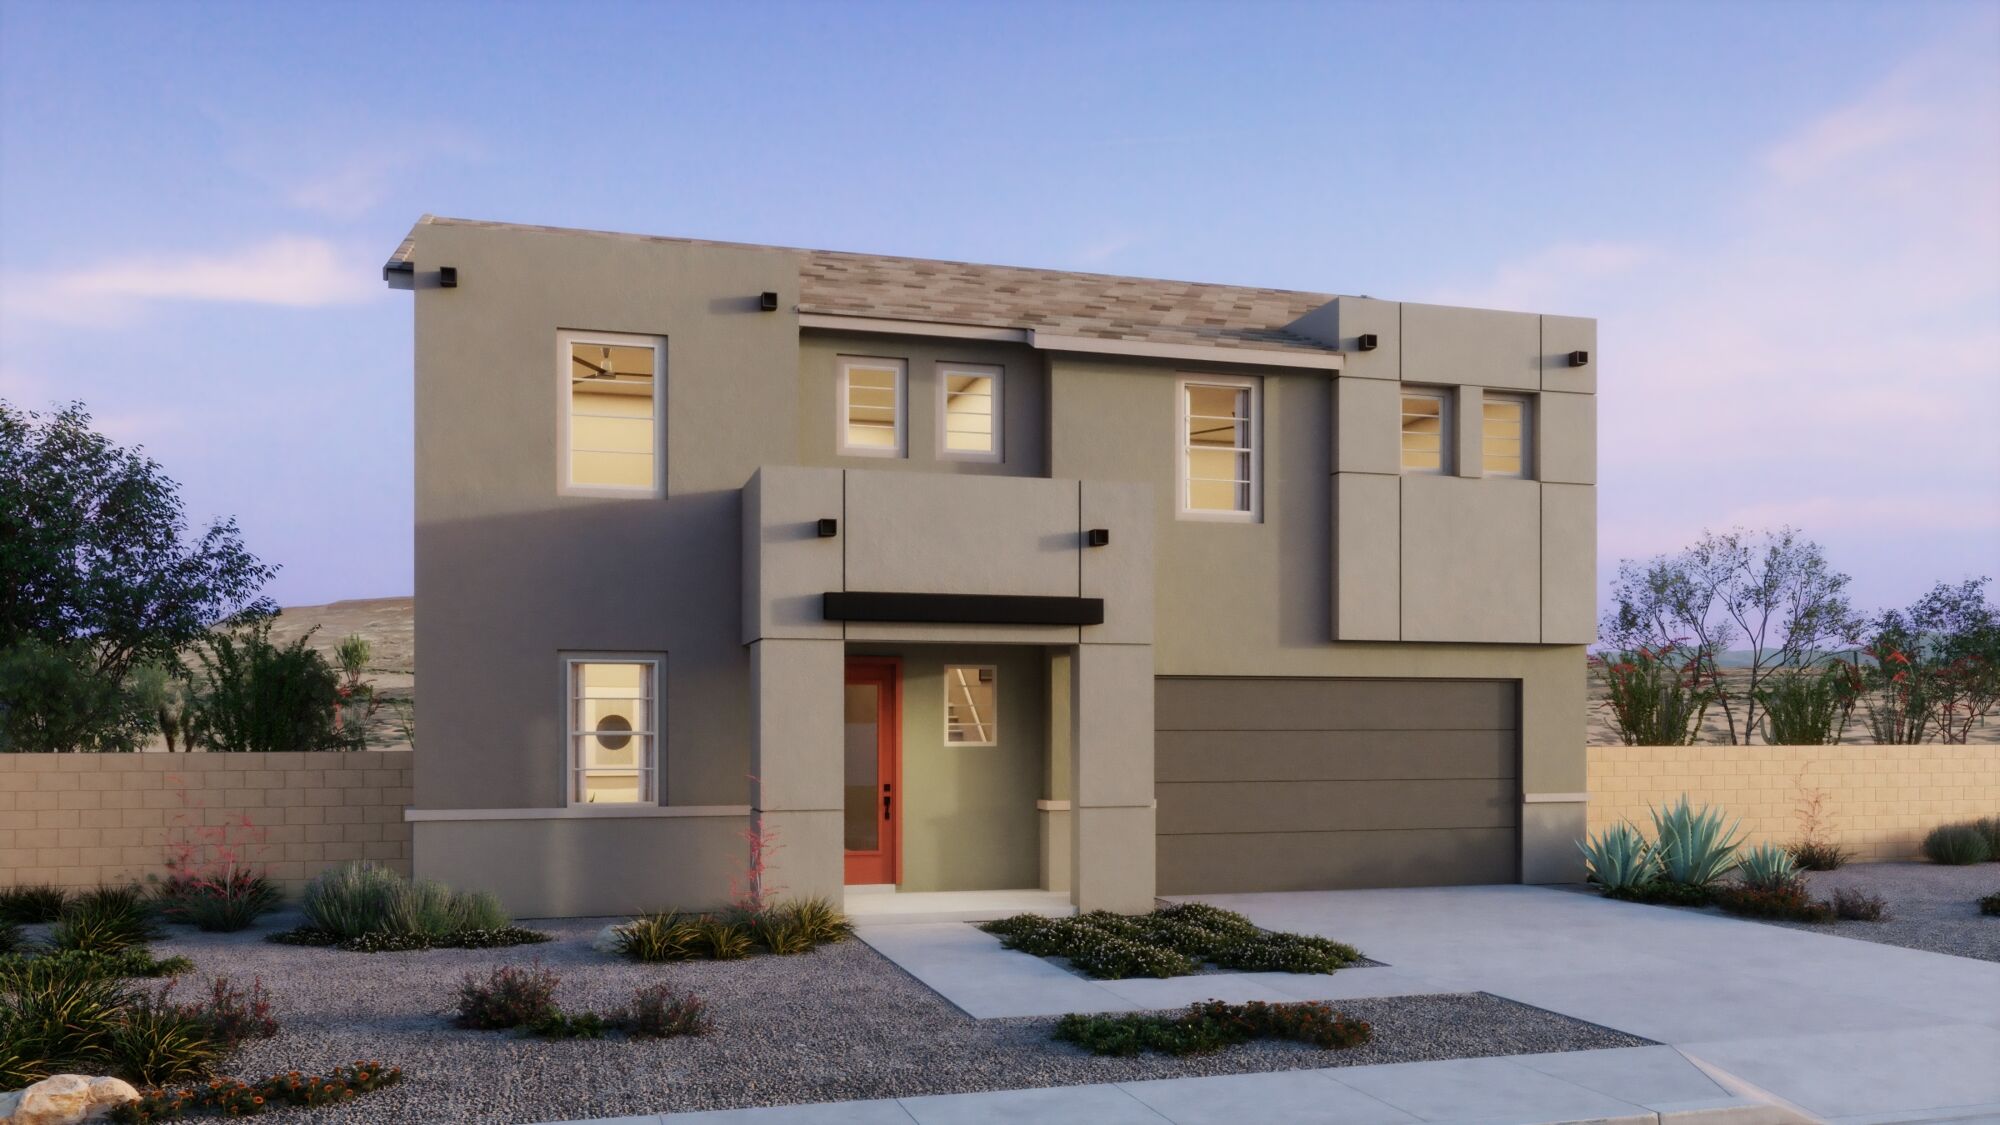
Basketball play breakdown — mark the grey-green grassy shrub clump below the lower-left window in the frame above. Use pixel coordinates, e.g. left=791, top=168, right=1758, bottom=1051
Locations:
left=268, top=863, right=548, bottom=953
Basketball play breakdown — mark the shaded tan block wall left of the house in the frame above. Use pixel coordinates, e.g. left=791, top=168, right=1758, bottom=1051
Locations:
left=0, top=751, right=414, bottom=893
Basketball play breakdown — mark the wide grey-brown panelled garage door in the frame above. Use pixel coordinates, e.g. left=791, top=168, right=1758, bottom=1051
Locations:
left=1154, top=677, right=1520, bottom=895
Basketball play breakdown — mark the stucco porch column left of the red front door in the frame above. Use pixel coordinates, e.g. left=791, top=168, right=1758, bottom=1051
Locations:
left=750, top=639, right=846, bottom=905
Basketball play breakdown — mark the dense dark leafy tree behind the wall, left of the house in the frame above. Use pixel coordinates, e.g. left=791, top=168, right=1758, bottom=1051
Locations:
left=0, top=402, right=276, bottom=751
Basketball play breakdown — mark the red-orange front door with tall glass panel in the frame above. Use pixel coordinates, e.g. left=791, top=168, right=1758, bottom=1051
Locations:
left=844, top=657, right=902, bottom=883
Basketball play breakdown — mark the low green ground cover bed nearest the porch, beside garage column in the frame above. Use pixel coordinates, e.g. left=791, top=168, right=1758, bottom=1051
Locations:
left=980, top=903, right=1362, bottom=981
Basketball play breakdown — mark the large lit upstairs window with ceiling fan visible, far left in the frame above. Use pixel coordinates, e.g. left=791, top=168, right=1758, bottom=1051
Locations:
left=560, top=332, right=666, bottom=496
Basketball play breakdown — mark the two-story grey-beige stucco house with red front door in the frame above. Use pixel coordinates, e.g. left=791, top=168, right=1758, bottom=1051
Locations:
left=384, top=216, right=1596, bottom=915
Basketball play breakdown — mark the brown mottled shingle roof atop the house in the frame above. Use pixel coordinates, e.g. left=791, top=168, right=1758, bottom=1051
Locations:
left=390, top=214, right=1334, bottom=352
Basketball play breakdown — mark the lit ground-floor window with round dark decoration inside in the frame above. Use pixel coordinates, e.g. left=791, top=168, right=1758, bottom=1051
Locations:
left=566, top=657, right=660, bottom=805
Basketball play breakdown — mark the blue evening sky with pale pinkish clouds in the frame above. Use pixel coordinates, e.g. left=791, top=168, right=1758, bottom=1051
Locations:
left=0, top=0, right=2000, bottom=609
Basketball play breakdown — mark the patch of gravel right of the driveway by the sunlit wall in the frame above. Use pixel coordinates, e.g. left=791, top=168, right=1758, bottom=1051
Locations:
left=1770, top=863, right=2000, bottom=961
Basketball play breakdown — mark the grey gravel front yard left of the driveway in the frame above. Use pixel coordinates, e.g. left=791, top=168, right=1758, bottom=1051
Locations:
left=137, top=915, right=1648, bottom=1123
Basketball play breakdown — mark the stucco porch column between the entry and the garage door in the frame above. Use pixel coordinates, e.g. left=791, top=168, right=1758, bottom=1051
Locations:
left=1070, top=645, right=1156, bottom=915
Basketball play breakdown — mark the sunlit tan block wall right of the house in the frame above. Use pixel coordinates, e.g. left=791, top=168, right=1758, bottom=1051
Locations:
left=1590, top=745, right=2000, bottom=861
